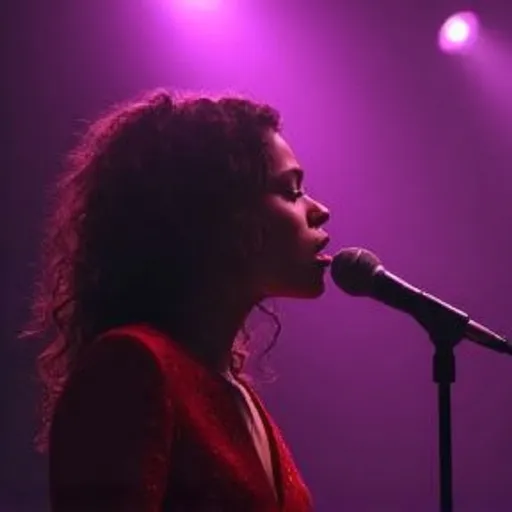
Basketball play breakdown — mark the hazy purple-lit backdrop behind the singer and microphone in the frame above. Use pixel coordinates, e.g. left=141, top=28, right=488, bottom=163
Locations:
left=0, top=0, right=512, bottom=512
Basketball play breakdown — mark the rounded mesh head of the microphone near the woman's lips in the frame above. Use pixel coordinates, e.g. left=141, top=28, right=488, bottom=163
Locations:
left=331, top=247, right=381, bottom=296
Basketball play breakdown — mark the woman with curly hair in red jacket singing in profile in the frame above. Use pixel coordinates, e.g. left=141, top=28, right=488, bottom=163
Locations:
left=27, top=91, right=330, bottom=512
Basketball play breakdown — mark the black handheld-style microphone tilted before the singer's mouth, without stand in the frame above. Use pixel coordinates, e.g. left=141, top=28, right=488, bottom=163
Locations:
left=331, top=247, right=512, bottom=355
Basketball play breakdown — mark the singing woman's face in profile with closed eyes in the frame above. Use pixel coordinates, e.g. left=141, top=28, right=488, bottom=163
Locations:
left=256, top=132, right=331, bottom=298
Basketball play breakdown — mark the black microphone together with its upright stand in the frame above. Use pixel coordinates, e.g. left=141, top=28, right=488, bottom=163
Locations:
left=331, top=248, right=512, bottom=512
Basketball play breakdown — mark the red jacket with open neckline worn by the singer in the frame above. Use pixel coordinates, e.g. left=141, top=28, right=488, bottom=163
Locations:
left=49, top=325, right=312, bottom=512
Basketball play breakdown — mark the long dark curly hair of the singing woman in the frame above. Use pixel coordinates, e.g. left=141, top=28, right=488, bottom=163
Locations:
left=25, top=90, right=280, bottom=450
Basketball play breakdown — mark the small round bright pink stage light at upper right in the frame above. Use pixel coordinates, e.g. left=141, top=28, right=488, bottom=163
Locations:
left=438, top=11, right=479, bottom=53
